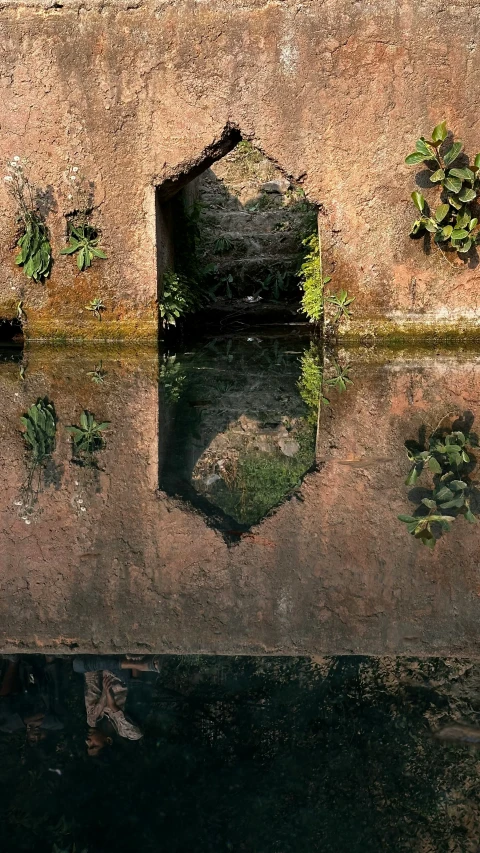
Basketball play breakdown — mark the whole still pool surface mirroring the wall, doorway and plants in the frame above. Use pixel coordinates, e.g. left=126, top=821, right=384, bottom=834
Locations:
left=0, top=332, right=480, bottom=853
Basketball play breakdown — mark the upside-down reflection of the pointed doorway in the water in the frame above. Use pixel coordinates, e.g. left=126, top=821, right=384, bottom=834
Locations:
left=159, top=337, right=318, bottom=532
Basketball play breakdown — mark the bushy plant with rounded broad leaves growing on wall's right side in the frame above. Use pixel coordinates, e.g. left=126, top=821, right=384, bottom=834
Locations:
left=405, top=121, right=480, bottom=255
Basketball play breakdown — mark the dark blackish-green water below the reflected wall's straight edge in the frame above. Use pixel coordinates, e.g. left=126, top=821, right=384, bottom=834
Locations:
left=0, top=656, right=478, bottom=853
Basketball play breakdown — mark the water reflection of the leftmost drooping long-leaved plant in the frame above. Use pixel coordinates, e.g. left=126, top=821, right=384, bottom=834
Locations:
left=20, top=397, right=57, bottom=512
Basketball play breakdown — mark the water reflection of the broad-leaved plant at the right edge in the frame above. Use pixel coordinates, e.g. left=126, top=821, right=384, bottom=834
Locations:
left=398, top=413, right=478, bottom=548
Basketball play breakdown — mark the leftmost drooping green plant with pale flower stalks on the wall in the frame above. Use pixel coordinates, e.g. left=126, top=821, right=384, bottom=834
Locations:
left=4, top=156, right=52, bottom=282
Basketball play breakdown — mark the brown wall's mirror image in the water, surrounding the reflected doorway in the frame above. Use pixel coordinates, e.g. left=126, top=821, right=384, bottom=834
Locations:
left=0, top=342, right=480, bottom=656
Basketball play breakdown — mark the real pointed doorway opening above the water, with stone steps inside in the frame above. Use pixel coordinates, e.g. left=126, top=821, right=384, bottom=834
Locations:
left=156, top=125, right=318, bottom=338
